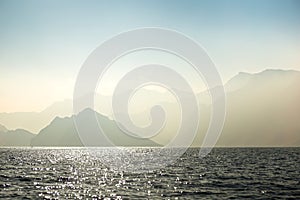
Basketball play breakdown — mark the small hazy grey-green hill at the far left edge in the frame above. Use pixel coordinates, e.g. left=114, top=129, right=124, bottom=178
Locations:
left=0, top=129, right=35, bottom=146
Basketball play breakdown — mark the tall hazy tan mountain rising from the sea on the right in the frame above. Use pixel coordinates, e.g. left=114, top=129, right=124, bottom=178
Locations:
left=194, top=70, right=300, bottom=146
